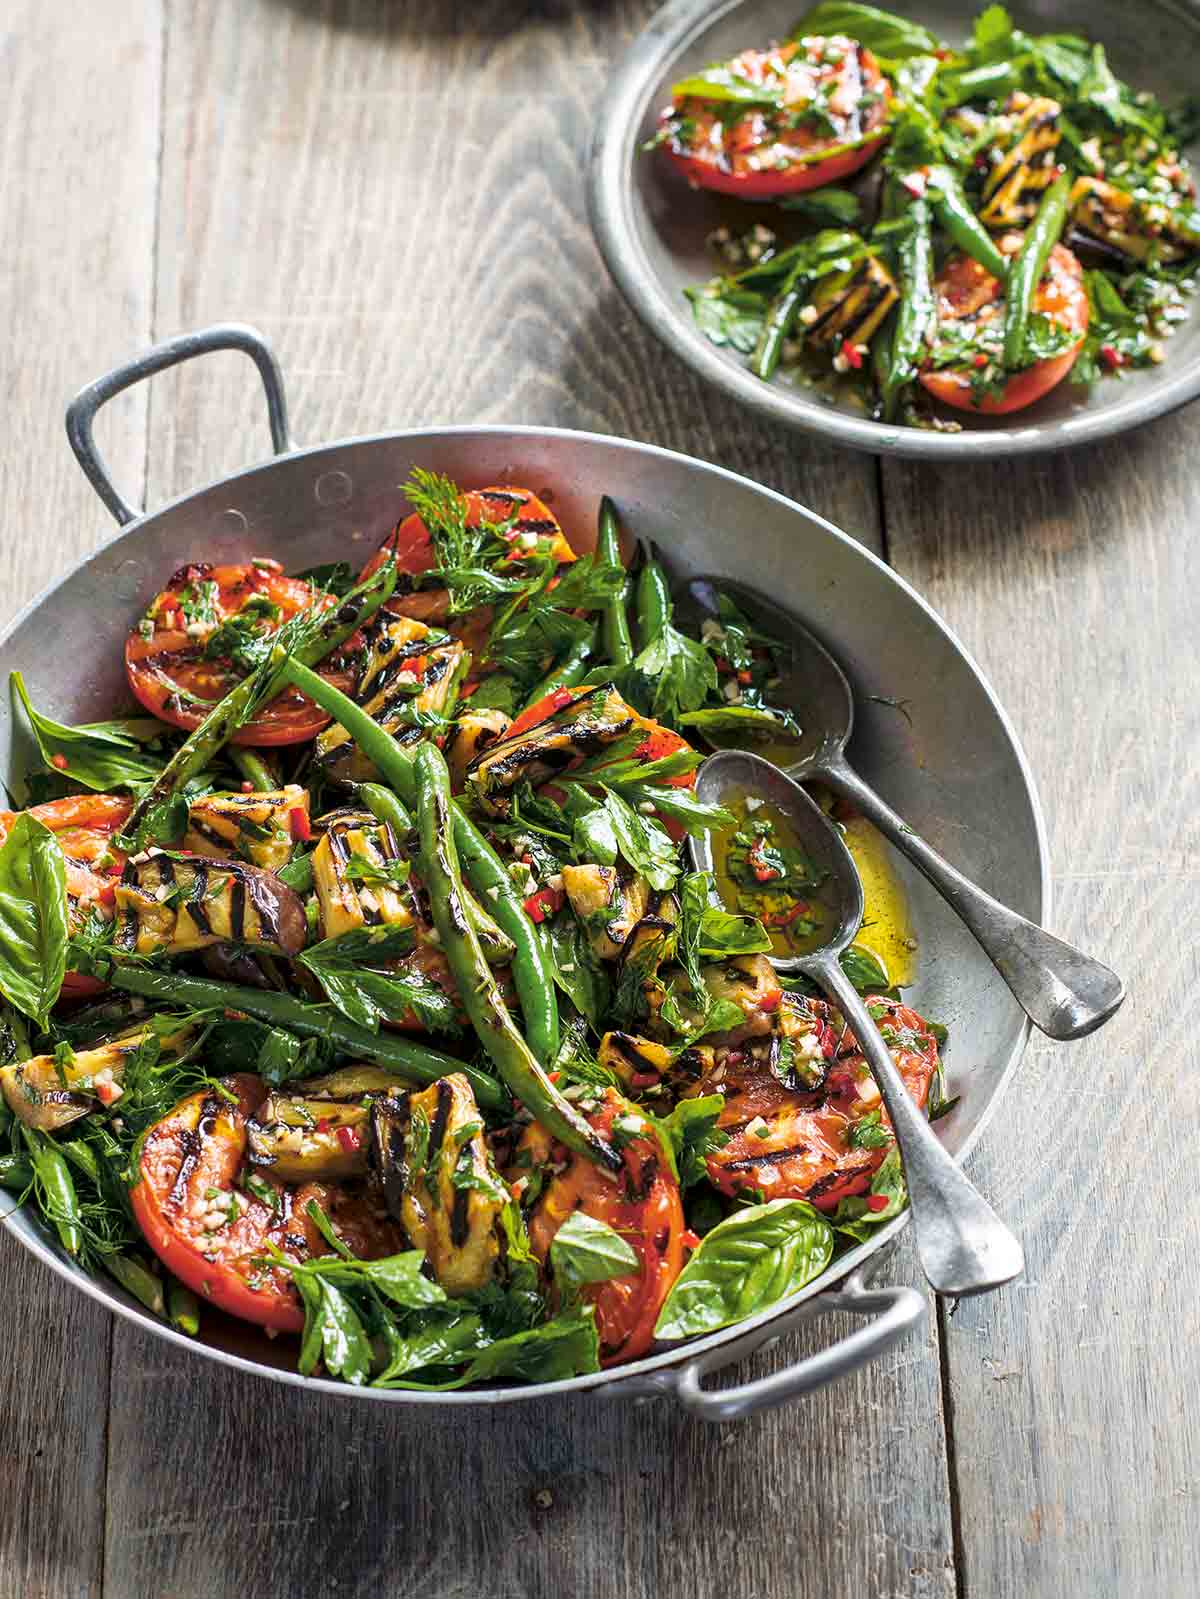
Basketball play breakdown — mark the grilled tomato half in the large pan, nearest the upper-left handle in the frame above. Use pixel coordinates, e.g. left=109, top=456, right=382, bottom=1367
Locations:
left=125, top=561, right=354, bottom=745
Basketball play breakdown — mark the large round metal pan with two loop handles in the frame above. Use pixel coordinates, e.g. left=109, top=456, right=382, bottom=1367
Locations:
left=0, top=328, right=1048, bottom=1417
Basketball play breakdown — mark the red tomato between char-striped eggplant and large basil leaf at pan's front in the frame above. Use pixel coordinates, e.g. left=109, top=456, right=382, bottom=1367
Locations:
left=530, top=1089, right=683, bottom=1366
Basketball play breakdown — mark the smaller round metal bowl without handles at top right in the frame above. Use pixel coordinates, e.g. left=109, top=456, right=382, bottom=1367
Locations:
left=587, top=0, right=1200, bottom=461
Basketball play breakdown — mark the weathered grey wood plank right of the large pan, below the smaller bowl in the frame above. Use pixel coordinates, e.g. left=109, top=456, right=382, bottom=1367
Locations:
left=885, top=413, right=1200, bottom=1599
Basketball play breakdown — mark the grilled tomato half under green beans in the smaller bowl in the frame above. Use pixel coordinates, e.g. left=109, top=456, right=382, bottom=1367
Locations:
left=920, top=245, right=1090, bottom=416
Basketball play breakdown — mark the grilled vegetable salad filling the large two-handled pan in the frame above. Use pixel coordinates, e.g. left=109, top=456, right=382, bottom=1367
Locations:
left=0, top=472, right=941, bottom=1388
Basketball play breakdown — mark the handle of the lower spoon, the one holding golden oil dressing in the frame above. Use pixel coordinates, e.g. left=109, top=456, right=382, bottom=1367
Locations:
left=810, top=956, right=1026, bottom=1295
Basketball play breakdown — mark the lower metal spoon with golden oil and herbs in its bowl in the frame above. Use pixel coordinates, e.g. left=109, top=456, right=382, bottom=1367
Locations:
left=688, top=750, right=1024, bottom=1295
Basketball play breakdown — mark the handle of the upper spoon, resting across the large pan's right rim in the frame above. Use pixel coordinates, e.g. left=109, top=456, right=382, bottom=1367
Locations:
left=821, top=760, right=1125, bottom=1038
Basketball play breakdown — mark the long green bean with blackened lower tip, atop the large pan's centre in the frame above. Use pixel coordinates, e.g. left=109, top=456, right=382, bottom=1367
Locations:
left=413, top=744, right=622, bottom=1172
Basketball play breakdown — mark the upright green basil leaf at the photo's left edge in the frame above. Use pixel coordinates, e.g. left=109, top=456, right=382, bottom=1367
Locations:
left=0, top=812, right=67, bottom=1028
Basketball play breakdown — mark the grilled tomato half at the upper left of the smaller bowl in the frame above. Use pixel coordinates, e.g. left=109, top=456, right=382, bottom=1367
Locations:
left=662, top=35, right=891, bottom=200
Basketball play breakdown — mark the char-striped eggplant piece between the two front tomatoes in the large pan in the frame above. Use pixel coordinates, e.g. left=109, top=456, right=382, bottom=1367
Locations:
left=371, top=1071, right=507, bottom=1294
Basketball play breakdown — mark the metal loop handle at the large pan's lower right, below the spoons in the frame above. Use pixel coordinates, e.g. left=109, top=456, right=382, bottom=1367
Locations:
left=597, top=1262, right=926, bottom=1422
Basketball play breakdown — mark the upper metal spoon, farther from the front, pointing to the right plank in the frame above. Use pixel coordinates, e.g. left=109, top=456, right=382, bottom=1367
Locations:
left=678, top=577, right=1125, bottom=1039
